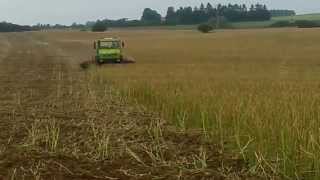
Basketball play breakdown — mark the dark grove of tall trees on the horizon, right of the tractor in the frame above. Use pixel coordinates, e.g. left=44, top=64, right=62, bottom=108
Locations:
left=96, top=3, right=272, bottom=27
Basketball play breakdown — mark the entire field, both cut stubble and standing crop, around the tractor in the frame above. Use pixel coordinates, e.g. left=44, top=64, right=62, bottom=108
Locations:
left=0, top=28, right=320, bottom=179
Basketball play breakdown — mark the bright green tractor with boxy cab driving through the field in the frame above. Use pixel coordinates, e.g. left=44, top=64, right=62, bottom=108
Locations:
left=94, top=38, right=124, bottom=64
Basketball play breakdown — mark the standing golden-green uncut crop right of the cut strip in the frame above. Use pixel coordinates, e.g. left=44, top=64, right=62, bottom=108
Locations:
left=44, top=29, right=320, bottom=179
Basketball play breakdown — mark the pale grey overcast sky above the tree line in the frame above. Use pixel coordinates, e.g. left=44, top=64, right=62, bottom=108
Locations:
left=0, top=0, right=320, bottom=25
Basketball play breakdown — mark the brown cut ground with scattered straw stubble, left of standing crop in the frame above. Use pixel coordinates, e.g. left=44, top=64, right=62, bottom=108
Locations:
left=0, top=33, right=256, bottom=180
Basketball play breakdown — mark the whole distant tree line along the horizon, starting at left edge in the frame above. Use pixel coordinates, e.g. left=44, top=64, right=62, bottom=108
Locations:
left=0, top=3, right=296, bottom=32
